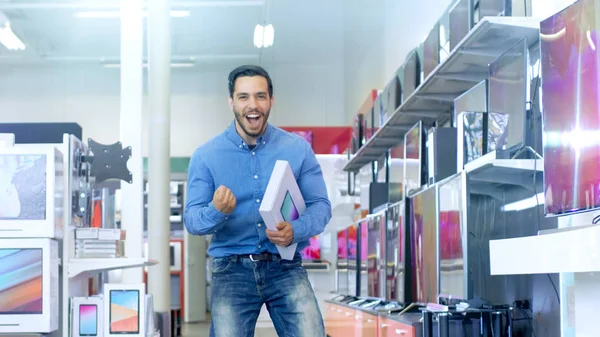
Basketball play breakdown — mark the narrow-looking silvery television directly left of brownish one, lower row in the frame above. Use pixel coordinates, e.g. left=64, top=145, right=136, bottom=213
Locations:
left=385, top=200, right=408, bottom=304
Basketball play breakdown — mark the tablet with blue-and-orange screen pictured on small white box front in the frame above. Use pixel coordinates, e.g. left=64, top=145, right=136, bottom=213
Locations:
left=109, top=290, right=140, bottom=334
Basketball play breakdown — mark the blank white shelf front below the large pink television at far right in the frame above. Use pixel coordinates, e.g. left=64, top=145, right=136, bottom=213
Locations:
left=490, top=225, right=600, bottom=275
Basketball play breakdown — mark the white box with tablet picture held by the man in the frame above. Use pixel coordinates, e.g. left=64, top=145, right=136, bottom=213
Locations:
left=259, top=160, right=306, bottom=260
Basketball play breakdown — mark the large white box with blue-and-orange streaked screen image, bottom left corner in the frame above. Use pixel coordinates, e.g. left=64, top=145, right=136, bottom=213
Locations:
left=0, top=239, right=60, bottom=334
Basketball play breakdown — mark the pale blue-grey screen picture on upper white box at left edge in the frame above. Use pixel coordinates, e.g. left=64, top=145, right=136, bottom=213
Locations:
left=0, top=154, right=46, bottom=220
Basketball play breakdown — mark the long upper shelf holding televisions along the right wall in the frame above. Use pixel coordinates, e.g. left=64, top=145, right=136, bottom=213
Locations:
left=344, top=17, right=539, bottom=172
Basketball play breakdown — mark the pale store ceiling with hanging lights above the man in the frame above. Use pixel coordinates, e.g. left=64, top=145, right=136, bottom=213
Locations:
left=0, top=0, right=343, bottom=63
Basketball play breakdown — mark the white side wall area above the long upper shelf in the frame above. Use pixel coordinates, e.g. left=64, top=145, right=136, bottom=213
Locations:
left=344, top=0, right=450, bottom=121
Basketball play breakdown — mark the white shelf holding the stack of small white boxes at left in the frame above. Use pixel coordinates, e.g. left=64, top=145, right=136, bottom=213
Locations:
left=69, top=258, right=158, bottom=278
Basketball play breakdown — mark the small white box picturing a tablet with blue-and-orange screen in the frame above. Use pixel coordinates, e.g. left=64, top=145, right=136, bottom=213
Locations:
left=104, top=283, right=146, bottom=337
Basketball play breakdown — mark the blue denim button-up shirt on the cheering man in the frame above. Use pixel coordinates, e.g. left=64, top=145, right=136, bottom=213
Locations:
left=184, top=122, right=331, bottom=257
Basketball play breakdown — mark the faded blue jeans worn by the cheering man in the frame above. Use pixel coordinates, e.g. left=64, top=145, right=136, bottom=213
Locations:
left=210, top=254, right=325, bottom=337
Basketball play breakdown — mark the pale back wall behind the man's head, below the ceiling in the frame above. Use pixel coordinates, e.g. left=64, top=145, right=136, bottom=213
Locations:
left=0, top=61, right=348, bottom=156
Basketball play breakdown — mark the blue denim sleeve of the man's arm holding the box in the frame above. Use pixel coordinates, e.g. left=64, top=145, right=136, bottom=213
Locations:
left=291, top=146, right=331, bottom=243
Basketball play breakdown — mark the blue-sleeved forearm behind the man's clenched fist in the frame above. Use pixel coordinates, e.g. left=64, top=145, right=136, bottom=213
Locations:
left=184, top=203, right=228, bottom=235
